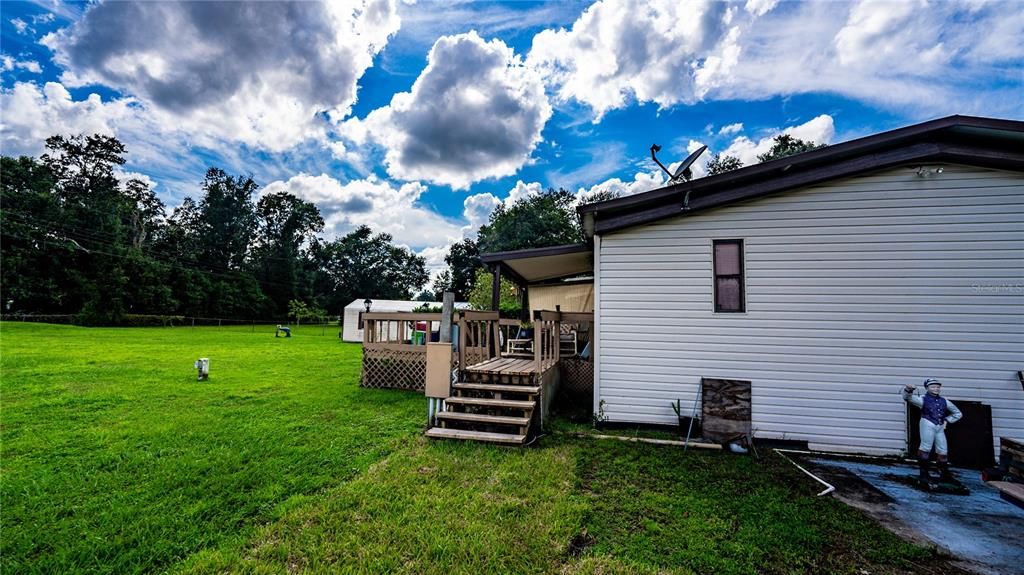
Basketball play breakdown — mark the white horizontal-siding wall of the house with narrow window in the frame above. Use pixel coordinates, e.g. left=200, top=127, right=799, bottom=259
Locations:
left=595, top=166, right=1024, bottom=452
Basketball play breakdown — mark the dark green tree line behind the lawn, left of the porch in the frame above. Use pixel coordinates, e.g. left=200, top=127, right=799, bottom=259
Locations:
left=0, top=135, right=428, bottom=324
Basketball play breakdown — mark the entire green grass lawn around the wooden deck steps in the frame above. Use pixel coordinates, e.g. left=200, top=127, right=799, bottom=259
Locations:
left=0, top=323, right=950, bottom=574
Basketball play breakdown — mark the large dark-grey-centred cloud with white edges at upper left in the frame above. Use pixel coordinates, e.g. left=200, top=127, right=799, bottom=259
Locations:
left=42, top=0, right=400, bottom=151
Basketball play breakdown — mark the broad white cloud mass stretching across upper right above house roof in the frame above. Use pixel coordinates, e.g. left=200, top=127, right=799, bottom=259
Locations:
left=527, top=0, right=1024, bottom=122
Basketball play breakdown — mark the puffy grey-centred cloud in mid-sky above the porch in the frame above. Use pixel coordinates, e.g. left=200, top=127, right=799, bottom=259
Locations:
left=339, top=32, right=551, bottom=188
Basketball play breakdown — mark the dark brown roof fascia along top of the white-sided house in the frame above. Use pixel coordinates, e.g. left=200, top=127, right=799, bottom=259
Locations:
left=579, top=116, right=1024, bottom=233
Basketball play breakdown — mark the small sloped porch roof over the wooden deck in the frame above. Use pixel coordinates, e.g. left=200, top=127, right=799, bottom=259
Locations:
left=480, top=244, right=594, bottom=285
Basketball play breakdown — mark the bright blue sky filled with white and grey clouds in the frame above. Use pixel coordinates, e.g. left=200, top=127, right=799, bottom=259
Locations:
left=0, top=0, right=1024, bottom=270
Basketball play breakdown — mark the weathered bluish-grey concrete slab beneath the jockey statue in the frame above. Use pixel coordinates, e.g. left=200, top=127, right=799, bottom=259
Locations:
left=809, top=457, right=1024, bottom=575
